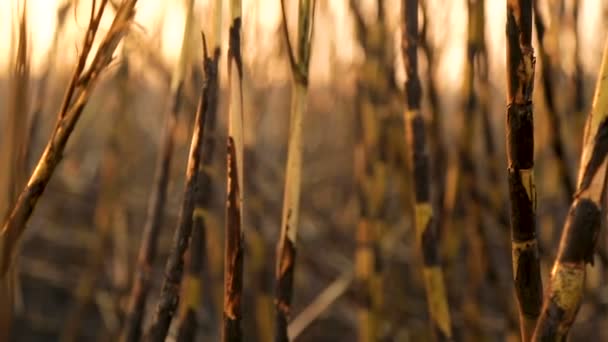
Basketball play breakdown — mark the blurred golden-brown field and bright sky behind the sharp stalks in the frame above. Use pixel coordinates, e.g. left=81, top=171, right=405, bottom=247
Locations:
left=0, top=0, right=608, bottom=342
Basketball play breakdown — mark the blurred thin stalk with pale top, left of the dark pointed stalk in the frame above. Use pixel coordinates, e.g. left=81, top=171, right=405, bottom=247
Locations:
left=121, top=0, right=193, bottom=342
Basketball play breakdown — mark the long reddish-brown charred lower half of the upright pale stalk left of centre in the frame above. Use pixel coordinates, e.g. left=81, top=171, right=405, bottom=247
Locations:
left=222, top=137, right=243, bottom=342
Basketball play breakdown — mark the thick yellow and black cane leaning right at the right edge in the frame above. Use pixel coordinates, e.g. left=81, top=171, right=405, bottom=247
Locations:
left=534, top=40, right=608, bottom=341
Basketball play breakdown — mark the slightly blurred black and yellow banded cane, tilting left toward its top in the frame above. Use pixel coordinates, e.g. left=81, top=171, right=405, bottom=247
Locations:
left=401, top=0, right=452, bottom=340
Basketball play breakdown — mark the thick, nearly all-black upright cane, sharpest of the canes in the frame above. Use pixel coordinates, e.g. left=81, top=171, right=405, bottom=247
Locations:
left=506, top=0, right=542, bottom=341
